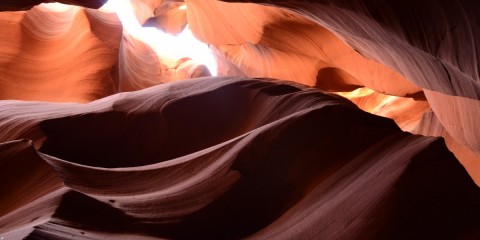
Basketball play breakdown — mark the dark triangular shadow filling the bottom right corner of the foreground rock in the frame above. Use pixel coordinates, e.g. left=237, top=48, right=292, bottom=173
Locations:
left=375, top=140, right=480, bottom=240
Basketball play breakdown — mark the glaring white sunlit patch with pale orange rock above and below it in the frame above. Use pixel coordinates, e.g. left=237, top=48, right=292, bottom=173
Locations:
left=101, top=0, right=216, bottom=91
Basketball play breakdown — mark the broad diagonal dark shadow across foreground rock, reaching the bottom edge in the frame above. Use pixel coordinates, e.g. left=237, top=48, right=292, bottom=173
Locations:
left=147, top=107, right=398, bottom=239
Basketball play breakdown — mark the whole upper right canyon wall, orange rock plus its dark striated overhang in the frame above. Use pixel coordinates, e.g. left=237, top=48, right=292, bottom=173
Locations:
left=181, top=0, right=480, bottom=184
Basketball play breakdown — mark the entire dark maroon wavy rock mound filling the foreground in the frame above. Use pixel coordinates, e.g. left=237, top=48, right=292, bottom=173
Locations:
left=0, top=77, right=480, bottom=239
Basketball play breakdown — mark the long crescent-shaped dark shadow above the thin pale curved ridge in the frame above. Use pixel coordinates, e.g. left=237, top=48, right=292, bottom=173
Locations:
left=40, top=81, right=321, bottom=168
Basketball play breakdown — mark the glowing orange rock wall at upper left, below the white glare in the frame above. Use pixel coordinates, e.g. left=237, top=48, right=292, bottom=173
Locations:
left=0, top=0, right=211, bottom=99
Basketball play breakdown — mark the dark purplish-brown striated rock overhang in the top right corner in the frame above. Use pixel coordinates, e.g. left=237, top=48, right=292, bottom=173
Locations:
left=220, top=0, right=480, bottom=99
